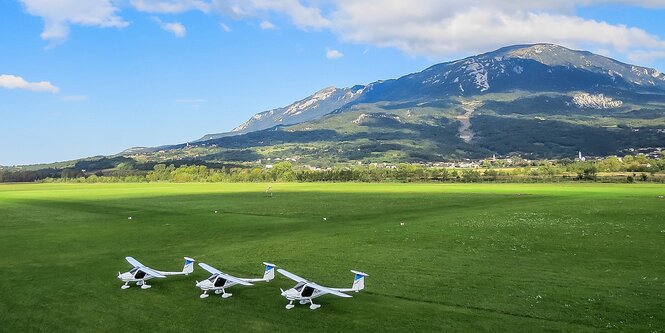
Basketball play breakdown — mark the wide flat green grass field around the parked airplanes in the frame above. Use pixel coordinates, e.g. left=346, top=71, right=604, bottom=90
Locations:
left=0, top=184, right=665, bottom=332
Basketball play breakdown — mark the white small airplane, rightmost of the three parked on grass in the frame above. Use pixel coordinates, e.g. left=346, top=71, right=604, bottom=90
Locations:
left=277, top=269, right=369, bottom=310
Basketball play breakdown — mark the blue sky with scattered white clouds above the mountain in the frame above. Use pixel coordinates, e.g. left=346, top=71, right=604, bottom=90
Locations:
left=0, top=0, right=665, bottom=165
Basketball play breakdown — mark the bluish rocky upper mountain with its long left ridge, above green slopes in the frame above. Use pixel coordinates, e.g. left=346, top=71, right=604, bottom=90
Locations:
left=199, top=44, right=665, bottom=141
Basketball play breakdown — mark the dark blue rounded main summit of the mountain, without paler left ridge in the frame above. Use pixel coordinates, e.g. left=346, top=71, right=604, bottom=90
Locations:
left=359, top=44, right=665, bottom=102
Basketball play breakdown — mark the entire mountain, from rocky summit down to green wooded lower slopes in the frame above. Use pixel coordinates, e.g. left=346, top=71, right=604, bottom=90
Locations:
left=104, top=44, right=665, bottom=166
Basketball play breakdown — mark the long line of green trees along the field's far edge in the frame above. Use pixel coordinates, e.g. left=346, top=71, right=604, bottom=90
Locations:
left=5, top=155, right=665, bottom=183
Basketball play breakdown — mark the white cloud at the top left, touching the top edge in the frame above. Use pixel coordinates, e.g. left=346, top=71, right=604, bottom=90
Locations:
left=21, top=0, right=128, bottom=43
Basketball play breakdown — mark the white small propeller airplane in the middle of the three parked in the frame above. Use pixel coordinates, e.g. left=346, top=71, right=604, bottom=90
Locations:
left=196, top=262, right=277, bottom=298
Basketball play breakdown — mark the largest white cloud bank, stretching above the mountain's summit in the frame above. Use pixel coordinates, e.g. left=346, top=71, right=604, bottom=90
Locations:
left=163, top=0, right=665, bottom=59
